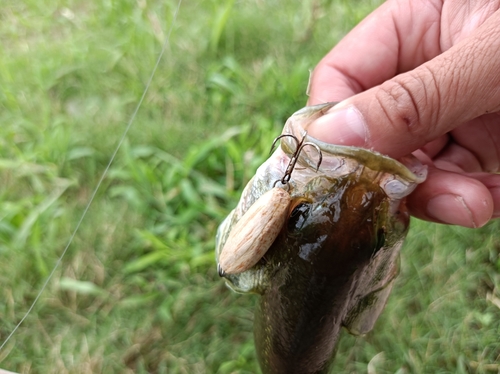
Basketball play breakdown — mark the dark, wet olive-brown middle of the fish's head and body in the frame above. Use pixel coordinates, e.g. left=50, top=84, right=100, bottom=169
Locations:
left=254, top=168, right=406, bottom=373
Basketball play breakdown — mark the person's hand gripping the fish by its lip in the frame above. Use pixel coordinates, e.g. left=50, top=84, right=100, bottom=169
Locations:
left=308, top=0, right=500, bottom=227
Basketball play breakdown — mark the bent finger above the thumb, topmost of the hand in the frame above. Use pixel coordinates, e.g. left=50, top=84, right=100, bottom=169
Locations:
left=308, top=1, right=441, bottom=105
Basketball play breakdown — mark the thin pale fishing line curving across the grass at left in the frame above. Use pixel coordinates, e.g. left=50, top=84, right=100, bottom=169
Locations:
left=0, top=0, right=182, bottom=351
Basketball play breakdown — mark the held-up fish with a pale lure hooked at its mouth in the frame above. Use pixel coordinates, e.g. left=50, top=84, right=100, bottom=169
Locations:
left=216, top=103, right=427, bottom=374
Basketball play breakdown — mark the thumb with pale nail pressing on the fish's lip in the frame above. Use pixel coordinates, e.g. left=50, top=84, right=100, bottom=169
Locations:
left=308, top=11, right=500, bottom=158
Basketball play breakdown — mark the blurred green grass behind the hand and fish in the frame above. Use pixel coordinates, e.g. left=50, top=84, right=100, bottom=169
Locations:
left=0, top=0, right=500, bottom=374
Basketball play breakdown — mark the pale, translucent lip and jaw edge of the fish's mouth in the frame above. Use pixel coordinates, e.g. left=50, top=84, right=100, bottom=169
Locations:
left=216, top=103, right=427, bottom=284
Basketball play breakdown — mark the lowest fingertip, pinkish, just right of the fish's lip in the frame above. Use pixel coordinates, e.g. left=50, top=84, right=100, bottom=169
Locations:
left=407, top=167, right=500, bottom=227
